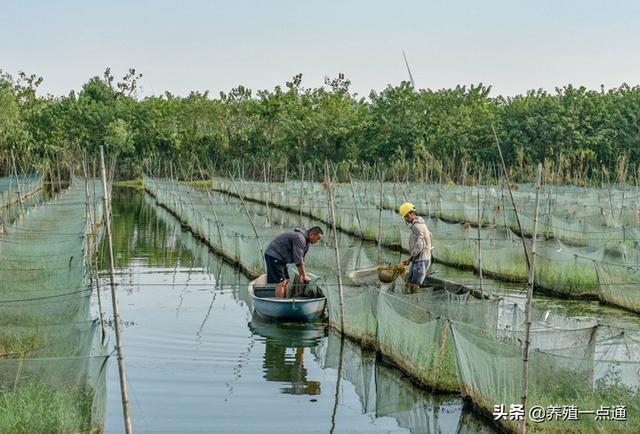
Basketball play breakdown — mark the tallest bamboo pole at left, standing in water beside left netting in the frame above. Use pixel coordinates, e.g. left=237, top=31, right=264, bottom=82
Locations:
left=100, top=146, right=133, bottom=434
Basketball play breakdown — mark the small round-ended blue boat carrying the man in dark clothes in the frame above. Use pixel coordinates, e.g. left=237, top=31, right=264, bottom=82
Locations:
left=249, top=274, right=327, bottom=321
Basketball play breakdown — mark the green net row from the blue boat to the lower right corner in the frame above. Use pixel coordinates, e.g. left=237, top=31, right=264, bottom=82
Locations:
left=325, top=284, right=640, bottom=433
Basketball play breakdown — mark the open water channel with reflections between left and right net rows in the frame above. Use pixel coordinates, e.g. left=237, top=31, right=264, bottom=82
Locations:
left=106, top=189, right=494, bottom=433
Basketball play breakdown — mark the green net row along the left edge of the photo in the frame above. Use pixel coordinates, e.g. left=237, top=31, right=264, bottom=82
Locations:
left=0, top=181, right=108, bottom=432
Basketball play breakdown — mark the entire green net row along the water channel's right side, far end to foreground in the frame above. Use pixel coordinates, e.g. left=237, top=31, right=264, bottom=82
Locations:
left=145, top=179, right=640, bottom=432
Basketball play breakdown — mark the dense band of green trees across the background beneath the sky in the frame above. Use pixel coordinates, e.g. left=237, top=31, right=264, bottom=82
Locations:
left=0, top=69, right=640, bottom=184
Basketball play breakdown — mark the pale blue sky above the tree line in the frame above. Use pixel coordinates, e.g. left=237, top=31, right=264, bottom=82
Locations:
left=0, top=0, right=640, bottom=96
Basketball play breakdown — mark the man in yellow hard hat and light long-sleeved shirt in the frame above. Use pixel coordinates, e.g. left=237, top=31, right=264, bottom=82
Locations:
left=399, top=202, right=433, bottom=292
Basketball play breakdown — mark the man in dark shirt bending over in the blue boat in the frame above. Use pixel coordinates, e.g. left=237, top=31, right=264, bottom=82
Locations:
left=264, top=226, right=324, bottom=298
